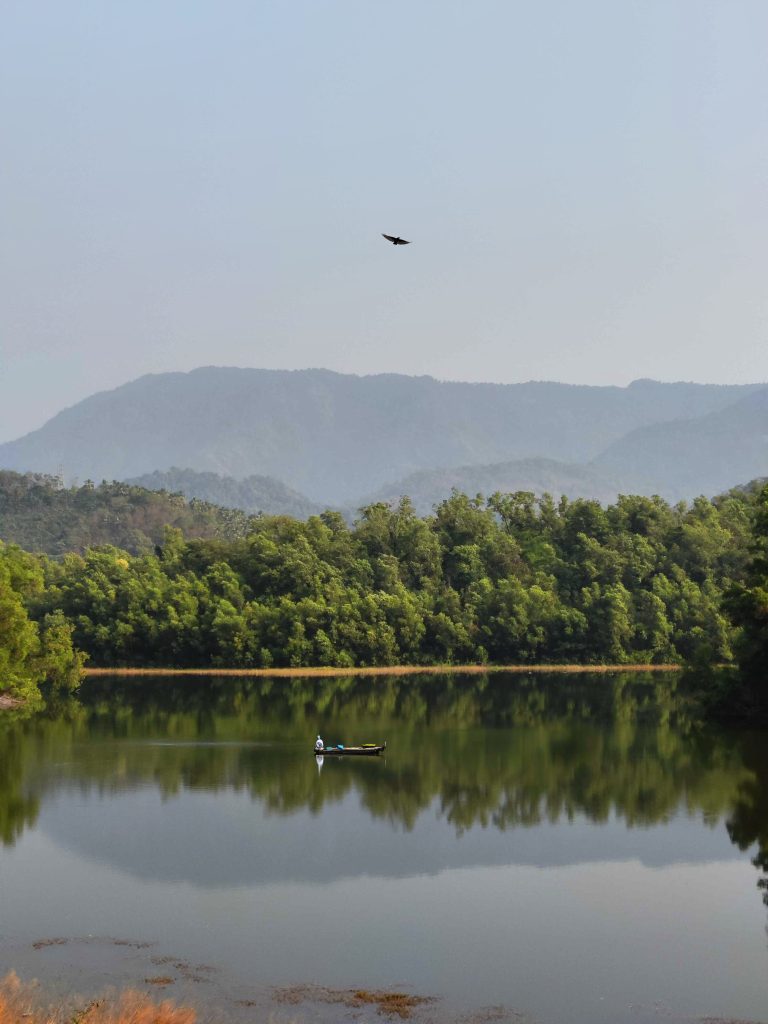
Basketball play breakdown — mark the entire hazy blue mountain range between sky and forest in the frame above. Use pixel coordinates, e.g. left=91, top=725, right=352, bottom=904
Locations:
left=0, top=367, right=768, bottom=515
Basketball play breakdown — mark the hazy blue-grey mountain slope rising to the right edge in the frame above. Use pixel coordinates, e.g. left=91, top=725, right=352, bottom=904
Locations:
left=592, top=388, right=768, bottom=500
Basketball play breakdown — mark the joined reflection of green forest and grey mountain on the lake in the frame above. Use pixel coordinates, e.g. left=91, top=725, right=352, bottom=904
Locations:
left=0, top=674, right=768, bottom=901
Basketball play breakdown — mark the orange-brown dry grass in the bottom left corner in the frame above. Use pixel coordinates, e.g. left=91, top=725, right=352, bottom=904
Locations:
left=0, top=973, right=197, bottom=1024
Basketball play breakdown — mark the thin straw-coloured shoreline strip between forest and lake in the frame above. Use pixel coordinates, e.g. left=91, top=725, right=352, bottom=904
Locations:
left=83, top=665, right=683, bottom=679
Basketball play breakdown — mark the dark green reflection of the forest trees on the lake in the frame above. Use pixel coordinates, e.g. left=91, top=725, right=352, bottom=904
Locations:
left=0, top=674, right=766, bottom=843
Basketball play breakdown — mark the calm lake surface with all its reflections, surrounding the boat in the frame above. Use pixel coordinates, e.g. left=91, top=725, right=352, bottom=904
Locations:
left=0, top=675, right=768, bottom=1024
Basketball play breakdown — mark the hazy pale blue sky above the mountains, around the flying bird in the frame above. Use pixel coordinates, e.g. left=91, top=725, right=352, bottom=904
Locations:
left=0, top=0, right=768, bottom=440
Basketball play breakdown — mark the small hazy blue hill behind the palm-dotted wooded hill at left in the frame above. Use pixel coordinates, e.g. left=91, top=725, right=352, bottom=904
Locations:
left=126, top=466, right=325, bottom=519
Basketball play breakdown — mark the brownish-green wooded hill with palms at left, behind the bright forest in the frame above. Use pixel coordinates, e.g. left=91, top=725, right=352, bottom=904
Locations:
left=0, top=471, right=262, bottom=555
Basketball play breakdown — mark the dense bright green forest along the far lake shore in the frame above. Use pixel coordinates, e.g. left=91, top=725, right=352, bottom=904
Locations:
left=0, top=484, right=768, bottom=693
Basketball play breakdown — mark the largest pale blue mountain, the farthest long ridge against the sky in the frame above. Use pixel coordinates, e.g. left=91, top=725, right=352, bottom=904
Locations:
left=0, top=367, right=755, bottom=504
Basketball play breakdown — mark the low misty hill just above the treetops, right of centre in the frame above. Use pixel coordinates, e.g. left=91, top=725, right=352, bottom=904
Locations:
left=359, top=459, right=626, bottom=515
